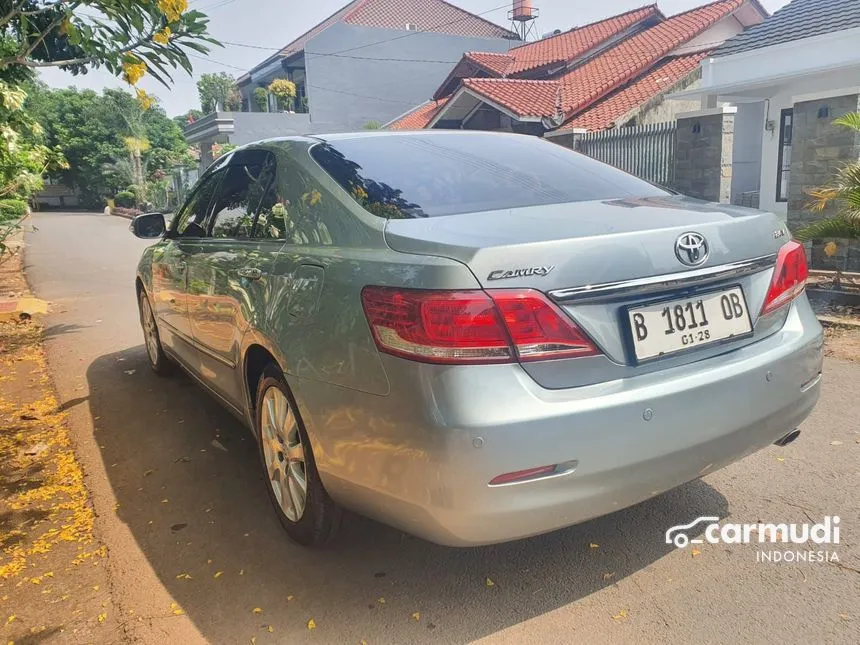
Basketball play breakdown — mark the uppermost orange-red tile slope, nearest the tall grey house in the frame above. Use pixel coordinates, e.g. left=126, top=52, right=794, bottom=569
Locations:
left=506, top=4, right=662, bottom=75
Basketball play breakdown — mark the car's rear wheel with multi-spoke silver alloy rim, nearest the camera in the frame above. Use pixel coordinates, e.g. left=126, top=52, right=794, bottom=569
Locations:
left=254, top=365, right=341, bottom=546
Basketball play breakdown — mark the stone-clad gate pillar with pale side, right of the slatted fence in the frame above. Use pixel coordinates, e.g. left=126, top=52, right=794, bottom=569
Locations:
left=672, top=107, right=737, bottom=203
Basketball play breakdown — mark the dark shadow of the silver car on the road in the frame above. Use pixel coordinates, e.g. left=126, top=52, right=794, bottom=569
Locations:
left=87, top=346, right=728, bottom=645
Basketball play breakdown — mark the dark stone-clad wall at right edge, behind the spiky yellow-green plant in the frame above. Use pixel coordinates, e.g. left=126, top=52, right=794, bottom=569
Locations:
left=788, top=94, right=860, bottom=271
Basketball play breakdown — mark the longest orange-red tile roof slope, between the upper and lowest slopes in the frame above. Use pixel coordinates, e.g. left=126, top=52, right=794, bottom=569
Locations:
left=558, top=0, right=745, bottom=115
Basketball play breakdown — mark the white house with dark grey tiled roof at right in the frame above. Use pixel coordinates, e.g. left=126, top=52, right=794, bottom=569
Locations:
left=673, top=0, right=860, bottom=266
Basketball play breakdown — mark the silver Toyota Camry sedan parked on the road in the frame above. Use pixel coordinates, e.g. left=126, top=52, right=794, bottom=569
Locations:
left=132, top=131, right=822, bottom=546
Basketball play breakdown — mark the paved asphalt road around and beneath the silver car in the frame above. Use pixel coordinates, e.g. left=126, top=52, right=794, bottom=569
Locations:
left=27, top=214, right=860, bottom=645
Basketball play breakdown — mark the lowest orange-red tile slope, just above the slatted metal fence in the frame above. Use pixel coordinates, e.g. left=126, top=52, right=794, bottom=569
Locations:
left=559, top=52, right=708, bottom=130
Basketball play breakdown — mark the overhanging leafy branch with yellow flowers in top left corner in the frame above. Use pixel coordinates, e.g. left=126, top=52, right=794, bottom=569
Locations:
left=0, top=0, right=218, bottom=85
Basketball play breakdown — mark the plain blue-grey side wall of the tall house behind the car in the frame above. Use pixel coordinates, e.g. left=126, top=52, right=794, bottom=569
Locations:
left=305, top=23, right=518, bottom=130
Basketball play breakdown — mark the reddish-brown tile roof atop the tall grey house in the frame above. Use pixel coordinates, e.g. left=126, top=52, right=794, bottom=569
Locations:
left=251, top=0, right=518, bottom=72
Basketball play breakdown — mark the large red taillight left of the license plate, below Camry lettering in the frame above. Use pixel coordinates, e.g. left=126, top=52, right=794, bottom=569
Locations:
left=361, top=287, right=600, bottom=364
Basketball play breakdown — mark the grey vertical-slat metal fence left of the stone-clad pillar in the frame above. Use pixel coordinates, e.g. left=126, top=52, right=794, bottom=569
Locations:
left=574, top=121, right=677, bottom=187
